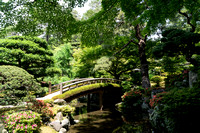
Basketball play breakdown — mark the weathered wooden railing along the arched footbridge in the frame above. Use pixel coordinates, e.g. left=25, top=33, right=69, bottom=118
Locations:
left=49, top=78, right=120, bottom=94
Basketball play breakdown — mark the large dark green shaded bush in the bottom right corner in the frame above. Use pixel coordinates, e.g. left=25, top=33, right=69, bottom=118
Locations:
left=150, top=88, right=200, bottom=133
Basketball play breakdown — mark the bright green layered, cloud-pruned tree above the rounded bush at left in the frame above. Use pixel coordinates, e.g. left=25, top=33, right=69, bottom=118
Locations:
left=0, top=36, right=58, bottom=78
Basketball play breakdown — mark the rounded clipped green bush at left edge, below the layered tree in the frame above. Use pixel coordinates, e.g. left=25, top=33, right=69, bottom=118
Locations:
left=0, top=65, right=39, bottom=105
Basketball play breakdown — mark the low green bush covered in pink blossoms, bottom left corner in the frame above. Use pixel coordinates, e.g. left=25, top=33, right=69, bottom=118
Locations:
left=1, top=111, right=42, bottom=133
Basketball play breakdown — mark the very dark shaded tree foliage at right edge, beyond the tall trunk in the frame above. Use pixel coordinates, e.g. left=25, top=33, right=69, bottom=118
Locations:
left=153, top=29, right=200, bottom=65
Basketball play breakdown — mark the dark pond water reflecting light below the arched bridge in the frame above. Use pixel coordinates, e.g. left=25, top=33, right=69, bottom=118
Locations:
left=68, top=99, right=152, bottom=133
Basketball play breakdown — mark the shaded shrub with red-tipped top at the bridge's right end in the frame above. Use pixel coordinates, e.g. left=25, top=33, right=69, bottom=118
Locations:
left=121, top=89, right=143, bottom=122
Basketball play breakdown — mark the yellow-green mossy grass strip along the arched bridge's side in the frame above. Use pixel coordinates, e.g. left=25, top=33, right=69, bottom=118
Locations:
left=53, top=83, right=120, bottom=100
